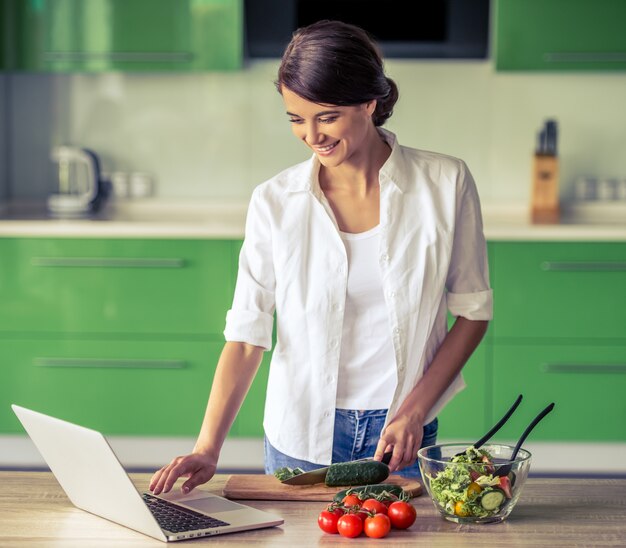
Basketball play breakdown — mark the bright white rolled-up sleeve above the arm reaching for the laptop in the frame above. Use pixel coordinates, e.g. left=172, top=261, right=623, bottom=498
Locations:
left=224, top=185, right=276, bottom=350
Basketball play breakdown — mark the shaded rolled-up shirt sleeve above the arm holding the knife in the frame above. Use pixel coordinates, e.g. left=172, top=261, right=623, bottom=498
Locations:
left=446, top=160, right=493, bottom=320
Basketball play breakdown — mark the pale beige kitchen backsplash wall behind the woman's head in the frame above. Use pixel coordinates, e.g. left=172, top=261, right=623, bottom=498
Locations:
left=0, top=60, right=626, bottom=206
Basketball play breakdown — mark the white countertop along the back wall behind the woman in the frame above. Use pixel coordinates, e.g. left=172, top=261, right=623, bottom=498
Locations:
left=0, top=199, right=626, bottom=241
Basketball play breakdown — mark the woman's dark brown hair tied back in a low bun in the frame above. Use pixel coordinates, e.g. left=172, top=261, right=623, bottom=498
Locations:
left=275, top=20, right=398, bottom=126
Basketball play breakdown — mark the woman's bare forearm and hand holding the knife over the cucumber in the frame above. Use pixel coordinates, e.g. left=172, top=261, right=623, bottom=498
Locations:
left=374, top=316, right=489, bottom=472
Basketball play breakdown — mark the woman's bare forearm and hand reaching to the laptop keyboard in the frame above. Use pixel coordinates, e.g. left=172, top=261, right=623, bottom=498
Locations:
left=150, top=342, right=263, bottom=495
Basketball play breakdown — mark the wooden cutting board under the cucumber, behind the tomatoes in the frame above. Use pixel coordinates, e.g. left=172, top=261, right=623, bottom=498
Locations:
left=223, top=474, right=422, bottom=502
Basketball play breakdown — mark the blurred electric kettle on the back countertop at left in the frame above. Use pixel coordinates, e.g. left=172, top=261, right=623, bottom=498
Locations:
left=48, top=146, right=109, bottom=217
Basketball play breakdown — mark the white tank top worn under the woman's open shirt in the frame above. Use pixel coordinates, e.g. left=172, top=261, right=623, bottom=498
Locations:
left=336, top=226, right=398, bottom=410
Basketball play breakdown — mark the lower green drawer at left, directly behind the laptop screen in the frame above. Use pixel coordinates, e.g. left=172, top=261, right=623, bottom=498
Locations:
left=0, top=339, right=224, bottom=436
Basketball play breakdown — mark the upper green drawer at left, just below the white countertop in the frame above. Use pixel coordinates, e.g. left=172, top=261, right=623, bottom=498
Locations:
left=0, top=238, right=235, bottom=335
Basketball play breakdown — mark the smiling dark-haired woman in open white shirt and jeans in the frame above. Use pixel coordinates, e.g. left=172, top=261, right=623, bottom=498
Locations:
left=150, top=21, right=492, bottom=494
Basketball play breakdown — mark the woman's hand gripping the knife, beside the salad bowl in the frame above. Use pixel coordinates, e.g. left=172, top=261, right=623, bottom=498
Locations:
left=374, top=413, right=424, bottom=472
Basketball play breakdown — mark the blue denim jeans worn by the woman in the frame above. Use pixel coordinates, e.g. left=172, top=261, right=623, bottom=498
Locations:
left=265, top=409, right=438, bottom=478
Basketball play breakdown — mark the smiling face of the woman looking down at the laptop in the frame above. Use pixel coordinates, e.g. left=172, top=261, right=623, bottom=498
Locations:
left=281, top=86, right=376, bottom=167
